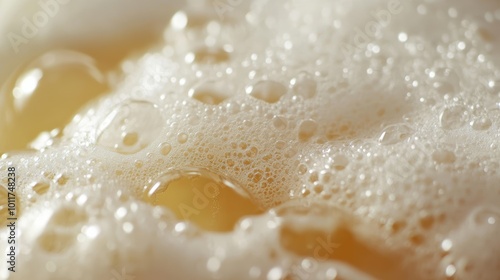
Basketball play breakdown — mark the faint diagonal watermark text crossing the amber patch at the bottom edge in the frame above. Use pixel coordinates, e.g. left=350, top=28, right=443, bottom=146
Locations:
left=291, top=234, right=340, bottom=280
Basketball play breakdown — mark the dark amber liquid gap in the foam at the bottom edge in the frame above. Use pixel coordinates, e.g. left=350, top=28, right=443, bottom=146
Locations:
left=276, top=203, right=405, bottom=279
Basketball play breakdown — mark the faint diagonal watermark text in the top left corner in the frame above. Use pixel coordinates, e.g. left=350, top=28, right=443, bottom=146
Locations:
left=7, top=0, right=71, bottom=54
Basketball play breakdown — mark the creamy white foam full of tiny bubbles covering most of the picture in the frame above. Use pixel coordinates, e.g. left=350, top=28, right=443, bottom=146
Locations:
left=0, top=1, right=500, bottom=280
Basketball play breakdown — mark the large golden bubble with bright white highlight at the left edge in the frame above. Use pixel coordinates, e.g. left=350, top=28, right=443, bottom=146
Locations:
left=0, top=51, right=109, bottom=153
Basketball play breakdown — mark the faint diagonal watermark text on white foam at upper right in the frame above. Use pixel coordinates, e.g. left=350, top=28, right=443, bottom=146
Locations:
left=342, top=0, right=403, bottom=57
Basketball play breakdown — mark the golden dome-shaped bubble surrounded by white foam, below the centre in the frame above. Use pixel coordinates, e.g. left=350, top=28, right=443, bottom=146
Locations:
left=144, top=170, right=262, bottom=232
